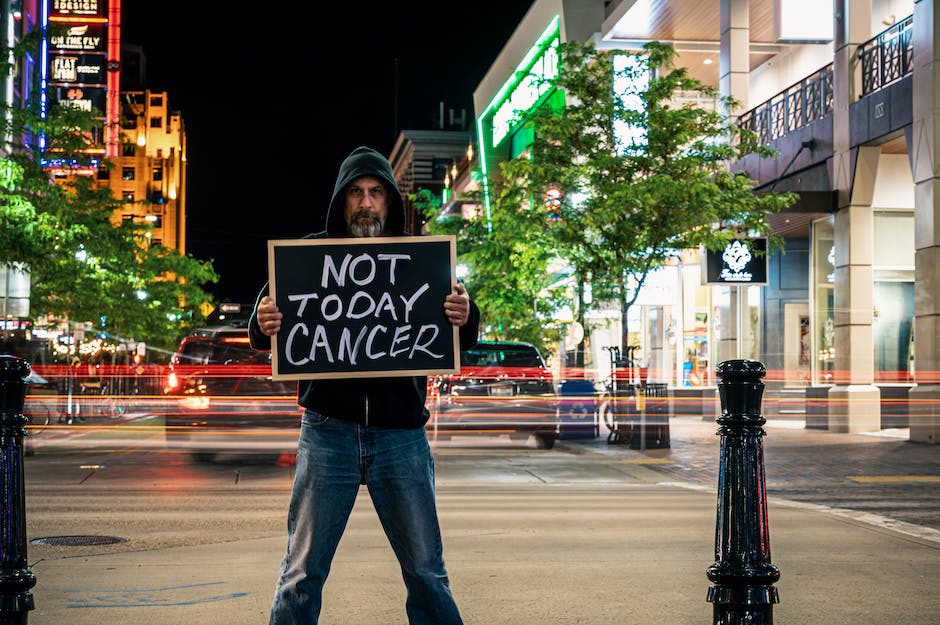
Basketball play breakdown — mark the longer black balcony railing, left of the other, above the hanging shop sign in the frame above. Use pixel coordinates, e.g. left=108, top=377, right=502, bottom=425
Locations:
left=738, top=63, right=832, bottom=145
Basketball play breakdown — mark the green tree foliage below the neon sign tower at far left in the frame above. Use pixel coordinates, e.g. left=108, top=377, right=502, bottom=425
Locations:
left=0, top=35, right=218, bottom=356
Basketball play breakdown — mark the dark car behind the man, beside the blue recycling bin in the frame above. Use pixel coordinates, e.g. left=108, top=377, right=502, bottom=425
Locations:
left=428, top=341, right=558, bottom=449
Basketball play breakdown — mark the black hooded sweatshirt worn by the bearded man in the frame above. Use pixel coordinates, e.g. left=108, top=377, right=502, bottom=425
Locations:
left=248, top=146, right=480, bottom=428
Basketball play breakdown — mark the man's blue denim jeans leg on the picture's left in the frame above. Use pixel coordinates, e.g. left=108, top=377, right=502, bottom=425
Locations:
left=270, top=411, right=361, bottom=625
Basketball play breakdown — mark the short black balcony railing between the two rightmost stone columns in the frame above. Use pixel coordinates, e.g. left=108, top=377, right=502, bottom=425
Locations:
left=858, top=15, right=914, bottom=96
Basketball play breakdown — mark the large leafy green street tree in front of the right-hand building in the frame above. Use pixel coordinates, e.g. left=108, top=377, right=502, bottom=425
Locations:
left=503, top=42, right=796, bottom=356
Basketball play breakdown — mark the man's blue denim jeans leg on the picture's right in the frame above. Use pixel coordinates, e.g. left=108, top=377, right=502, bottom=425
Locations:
left=365, top=428, right=463, bottom=625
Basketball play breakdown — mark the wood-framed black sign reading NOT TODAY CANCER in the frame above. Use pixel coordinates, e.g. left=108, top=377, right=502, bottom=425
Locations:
left=268, top=236, right=460, bottom=380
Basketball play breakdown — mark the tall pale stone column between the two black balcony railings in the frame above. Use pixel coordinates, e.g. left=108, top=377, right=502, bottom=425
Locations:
left=829, top=0, right=881, bottom=432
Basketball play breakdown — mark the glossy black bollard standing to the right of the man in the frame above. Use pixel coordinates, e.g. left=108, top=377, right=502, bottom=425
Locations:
left=707, top=360, right=780, bottom=625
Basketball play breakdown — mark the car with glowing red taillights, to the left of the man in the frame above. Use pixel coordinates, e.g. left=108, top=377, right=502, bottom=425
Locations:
left=163, top=322, right=302, bottom=459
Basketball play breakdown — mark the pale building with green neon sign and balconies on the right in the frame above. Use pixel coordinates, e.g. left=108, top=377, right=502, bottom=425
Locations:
left=474, top=0, right=940, bottom=443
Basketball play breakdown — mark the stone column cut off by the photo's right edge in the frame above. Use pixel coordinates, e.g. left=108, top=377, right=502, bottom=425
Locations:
left=908, top=0, right=940, bottom=444
